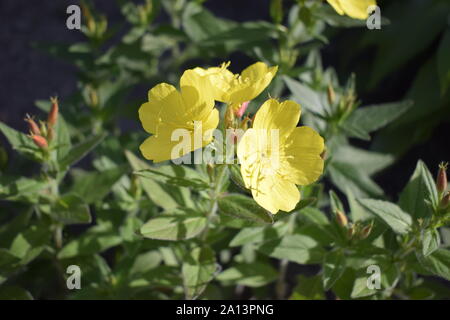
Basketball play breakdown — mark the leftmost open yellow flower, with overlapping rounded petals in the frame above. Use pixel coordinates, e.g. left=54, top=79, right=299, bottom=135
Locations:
left=139, top=70, right=219, bottom=162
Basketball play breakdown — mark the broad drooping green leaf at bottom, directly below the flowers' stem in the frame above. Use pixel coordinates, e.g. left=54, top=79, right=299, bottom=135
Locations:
left=181, top=247, right=217, bottom=300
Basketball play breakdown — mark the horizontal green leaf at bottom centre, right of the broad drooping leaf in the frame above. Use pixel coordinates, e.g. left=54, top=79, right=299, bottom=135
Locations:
left=216, top=262, right=278, bottom=288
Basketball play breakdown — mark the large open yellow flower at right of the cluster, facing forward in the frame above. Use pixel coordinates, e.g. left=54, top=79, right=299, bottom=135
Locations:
left=237, top=99, right=324, bottom=214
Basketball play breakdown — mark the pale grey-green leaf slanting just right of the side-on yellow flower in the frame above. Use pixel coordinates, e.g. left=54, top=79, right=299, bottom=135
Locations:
left=283, top=76, right=327, bottom=117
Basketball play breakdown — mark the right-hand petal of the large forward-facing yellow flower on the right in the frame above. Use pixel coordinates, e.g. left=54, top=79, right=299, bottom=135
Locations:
left=281, top=127, right=324, bottom=185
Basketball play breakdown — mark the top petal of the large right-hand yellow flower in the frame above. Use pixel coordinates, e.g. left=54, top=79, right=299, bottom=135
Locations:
left=253, top=99, right=301, bottom=143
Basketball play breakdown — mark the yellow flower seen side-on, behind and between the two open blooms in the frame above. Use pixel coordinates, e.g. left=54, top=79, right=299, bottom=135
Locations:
left=193, top=62, right=278, bottom=107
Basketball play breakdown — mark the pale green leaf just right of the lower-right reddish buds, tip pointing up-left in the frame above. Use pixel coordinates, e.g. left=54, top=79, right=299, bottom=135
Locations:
left=359, top=199, right=412, bottom=234
